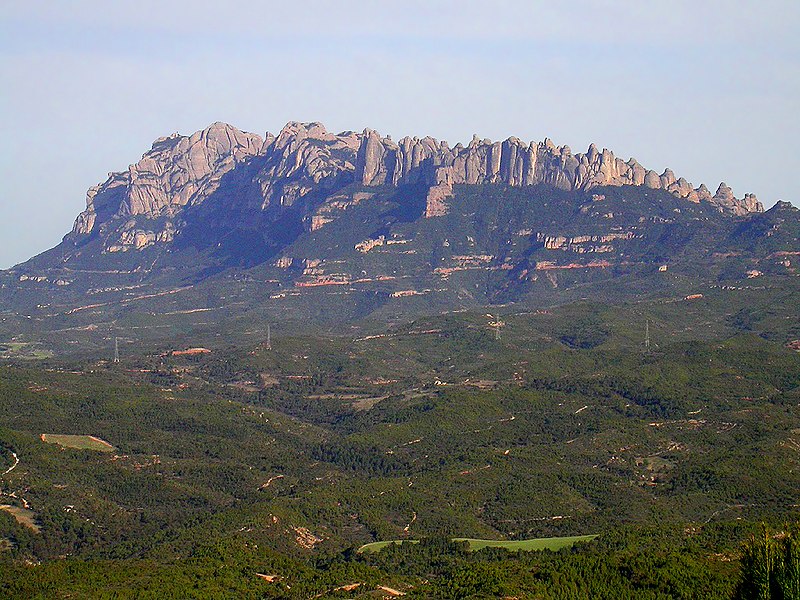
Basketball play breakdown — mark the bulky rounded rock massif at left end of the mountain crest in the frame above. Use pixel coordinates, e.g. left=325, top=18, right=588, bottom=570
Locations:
left=68, top=122, right=360, bottom=252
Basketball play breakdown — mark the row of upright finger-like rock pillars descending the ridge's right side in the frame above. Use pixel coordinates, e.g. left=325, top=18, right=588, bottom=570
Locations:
left=355, top=129, right=764, bottom=216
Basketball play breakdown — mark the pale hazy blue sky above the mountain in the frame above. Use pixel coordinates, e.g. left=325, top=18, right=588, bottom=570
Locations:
left=0, top=0, right=800, bottom=268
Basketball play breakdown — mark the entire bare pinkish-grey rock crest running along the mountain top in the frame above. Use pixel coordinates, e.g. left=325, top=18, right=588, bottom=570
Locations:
left=68, top=122, right=763, bottom=252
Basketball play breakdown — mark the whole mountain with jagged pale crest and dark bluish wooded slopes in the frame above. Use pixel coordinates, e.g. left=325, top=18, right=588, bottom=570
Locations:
left=0, top=122, right=800, bottom=346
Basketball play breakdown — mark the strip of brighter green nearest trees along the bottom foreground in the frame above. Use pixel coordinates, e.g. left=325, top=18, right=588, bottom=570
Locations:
left=0, top=530, right=735, bottom=600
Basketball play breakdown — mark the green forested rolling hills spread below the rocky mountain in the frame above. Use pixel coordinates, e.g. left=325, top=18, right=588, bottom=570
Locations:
left=0, top=303, right=800, bottom=598
